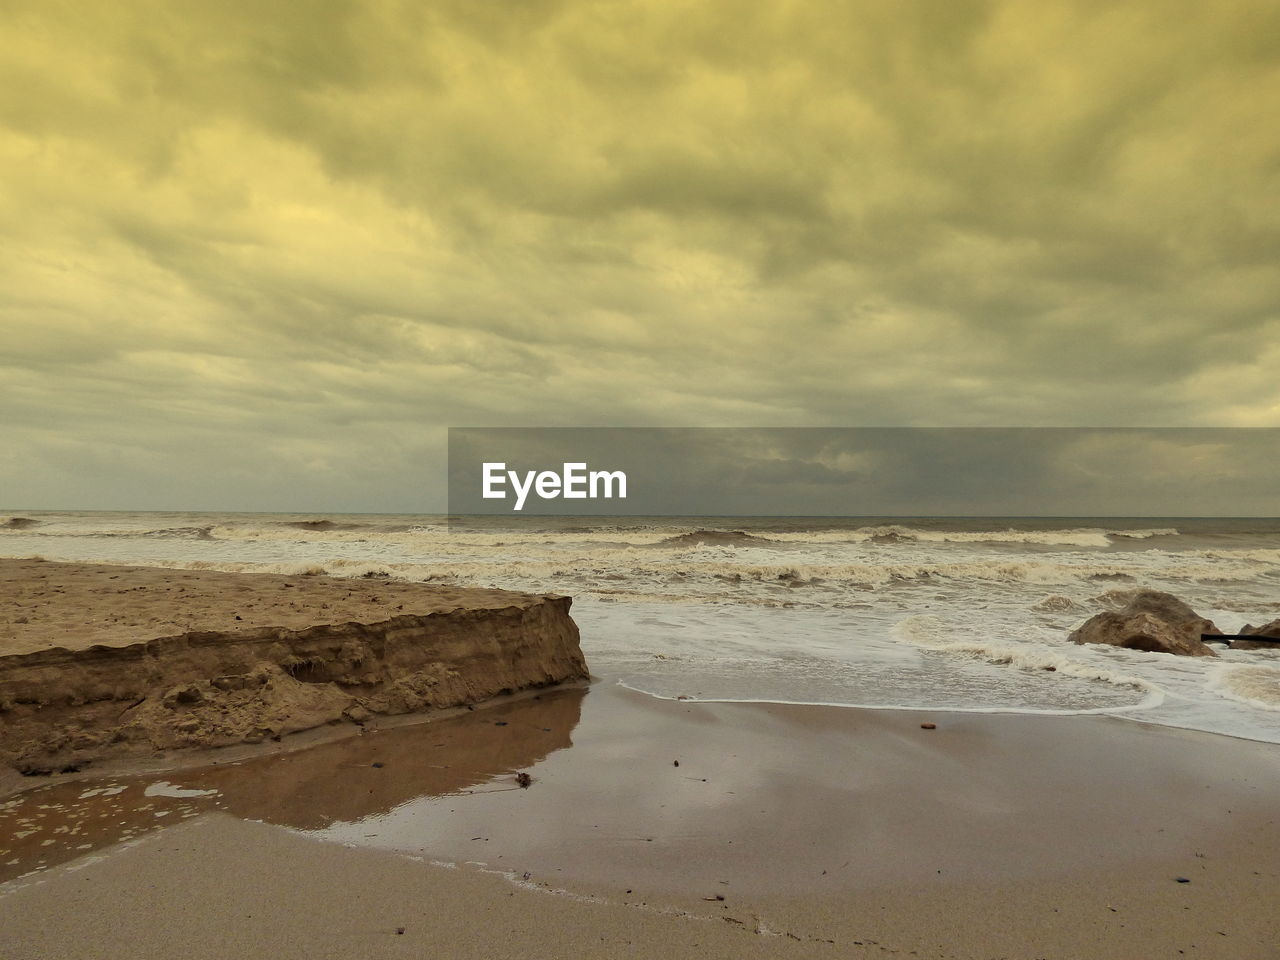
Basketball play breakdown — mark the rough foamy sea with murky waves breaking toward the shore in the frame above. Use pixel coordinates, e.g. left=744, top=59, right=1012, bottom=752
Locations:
left=0, top=512, right=1280, bottom=742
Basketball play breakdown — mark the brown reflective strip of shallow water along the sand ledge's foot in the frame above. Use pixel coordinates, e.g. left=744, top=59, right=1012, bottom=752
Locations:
left=0, top=689, right=586, bottom=882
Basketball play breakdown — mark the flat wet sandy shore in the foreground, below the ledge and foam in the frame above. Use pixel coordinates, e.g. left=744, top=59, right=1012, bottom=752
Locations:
left=0, top=682, right=1280, bottom=960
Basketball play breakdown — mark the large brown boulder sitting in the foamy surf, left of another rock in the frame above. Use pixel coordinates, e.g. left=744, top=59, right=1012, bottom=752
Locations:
left=1069, top=590, right=1222, bottom=657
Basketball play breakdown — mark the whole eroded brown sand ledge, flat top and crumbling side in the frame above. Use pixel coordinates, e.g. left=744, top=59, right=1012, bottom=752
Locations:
left=0, top=561, right=588, bottom=773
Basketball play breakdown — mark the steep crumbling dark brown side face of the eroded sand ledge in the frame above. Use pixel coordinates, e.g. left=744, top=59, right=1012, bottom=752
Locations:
left=0, top=564, right=588, bottom=773
